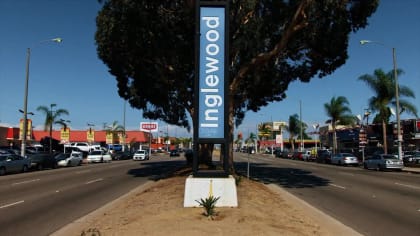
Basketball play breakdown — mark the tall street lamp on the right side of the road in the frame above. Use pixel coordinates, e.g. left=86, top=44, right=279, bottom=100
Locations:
left=360, top=40, right=402, bottom=160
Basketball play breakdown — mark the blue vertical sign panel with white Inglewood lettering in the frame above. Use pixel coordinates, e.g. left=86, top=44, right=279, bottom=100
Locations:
left=198, top=6, right=225, bottom=139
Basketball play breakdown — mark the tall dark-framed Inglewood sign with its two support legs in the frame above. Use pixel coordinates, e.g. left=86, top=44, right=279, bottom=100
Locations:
left=193, top=1, right=230, bottom=176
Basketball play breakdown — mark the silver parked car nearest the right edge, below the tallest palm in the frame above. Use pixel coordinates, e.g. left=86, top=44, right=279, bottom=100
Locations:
left=363, top=154, right=404, bottom=170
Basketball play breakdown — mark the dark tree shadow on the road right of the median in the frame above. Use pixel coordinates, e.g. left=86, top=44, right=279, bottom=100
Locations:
left=235, top=162, right=330, bottom=188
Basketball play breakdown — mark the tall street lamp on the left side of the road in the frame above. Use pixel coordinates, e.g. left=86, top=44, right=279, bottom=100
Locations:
left=20, top=38, right=63, bottom=156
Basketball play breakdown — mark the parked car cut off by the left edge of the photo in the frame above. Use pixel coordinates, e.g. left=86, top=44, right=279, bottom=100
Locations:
left=0, top=154, right=31, bottom=175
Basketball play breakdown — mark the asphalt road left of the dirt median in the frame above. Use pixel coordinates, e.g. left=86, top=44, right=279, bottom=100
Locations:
left=0, top=157, right=185, bottom=236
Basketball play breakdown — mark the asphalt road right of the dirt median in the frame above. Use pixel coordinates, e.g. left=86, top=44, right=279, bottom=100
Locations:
left=234, top=153, right=420, bottom=236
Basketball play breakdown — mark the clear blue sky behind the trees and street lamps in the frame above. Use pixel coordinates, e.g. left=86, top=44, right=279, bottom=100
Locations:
left=0, top=0, right=420, bottom=137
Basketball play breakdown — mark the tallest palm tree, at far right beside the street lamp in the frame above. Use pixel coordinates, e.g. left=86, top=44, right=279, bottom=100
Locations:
left=359, top=69, right=417, bottom=153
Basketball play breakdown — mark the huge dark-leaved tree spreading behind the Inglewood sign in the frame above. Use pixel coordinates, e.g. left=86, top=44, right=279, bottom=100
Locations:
left=95, top=0, right=378, bottom=170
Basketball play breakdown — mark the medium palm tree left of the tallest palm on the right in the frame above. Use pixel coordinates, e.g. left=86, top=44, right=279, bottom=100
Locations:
left=324, top=96, right=355, bottom=153
